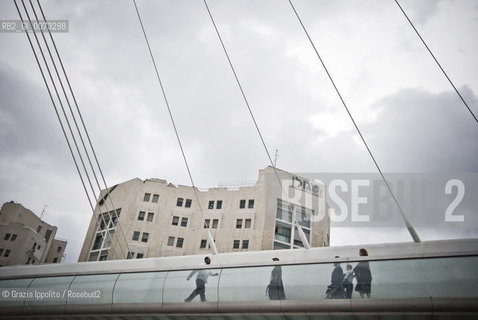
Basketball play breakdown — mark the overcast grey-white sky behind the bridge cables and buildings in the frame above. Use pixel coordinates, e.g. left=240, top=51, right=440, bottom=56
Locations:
left=0, top=0, right=478, bottom=262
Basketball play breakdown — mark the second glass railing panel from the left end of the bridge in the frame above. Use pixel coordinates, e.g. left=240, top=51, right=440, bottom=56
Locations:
left=25, top=276, right=74, bottom=306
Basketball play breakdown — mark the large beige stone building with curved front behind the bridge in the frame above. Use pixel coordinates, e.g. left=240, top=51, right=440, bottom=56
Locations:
left=78, top=167, right=330, bottom=262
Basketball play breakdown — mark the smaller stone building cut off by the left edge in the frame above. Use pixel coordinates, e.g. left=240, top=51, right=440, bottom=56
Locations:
left=0, top=201, right=67, bottom=267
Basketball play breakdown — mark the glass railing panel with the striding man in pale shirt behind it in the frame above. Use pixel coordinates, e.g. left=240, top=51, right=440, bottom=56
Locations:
left=163, top=269, right=220, bottom=303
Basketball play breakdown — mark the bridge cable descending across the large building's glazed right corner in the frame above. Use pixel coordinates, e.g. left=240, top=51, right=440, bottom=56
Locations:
left=203, top=0, right=310, bottom=249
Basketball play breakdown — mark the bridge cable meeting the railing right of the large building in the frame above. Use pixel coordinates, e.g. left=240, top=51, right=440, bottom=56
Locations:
left=288, top=0, right=420, bottom=242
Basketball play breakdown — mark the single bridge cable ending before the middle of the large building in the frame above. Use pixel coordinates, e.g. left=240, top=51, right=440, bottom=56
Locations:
left=133, top=0, right=217, bottom=254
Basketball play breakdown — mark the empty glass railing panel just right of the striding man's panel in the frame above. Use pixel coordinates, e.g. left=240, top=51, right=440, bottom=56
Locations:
left=219, top=267, right=273, bottom=302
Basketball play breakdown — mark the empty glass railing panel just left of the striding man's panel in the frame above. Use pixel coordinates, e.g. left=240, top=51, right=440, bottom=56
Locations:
left=113, top=272, right=167, bottom=303
